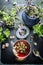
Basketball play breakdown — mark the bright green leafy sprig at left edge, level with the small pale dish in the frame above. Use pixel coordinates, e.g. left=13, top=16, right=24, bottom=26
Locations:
left=0, top=27, right=10, bottom=42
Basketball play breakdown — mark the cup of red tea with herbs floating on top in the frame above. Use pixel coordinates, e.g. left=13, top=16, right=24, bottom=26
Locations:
left=13, top=40, right=31, bottom=61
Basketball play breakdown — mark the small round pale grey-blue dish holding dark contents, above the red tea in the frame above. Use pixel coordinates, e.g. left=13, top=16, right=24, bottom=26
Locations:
left=16, top=26, right=29, bottom=39
